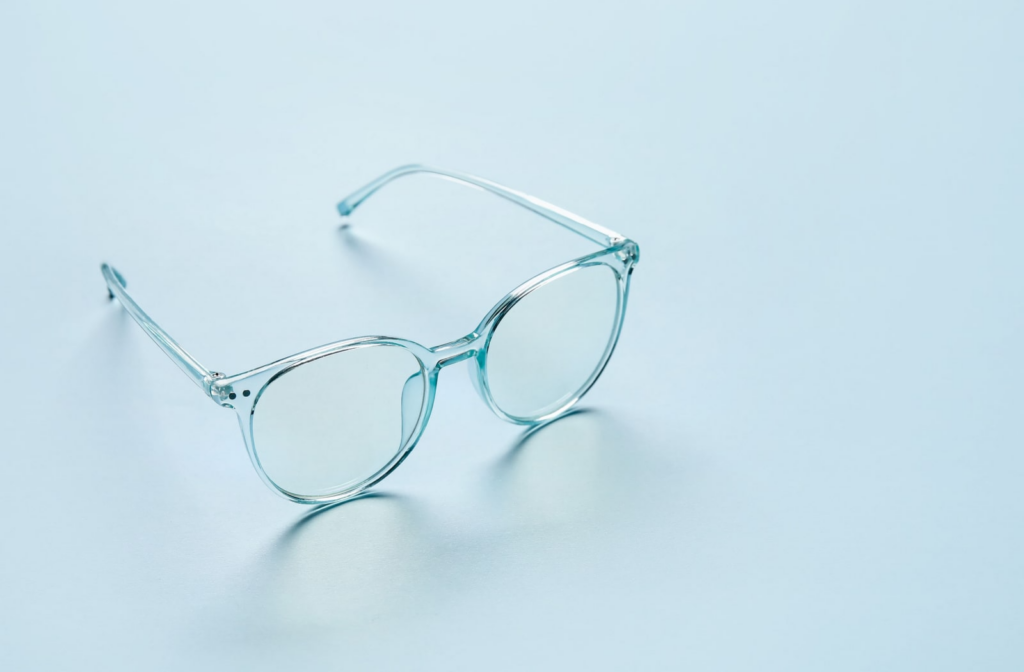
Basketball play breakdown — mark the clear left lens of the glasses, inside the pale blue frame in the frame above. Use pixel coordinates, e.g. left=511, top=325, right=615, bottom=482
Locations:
left=253, top=345, right=426, bottom=497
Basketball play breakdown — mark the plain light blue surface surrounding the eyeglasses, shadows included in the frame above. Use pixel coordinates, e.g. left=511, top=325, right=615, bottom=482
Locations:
left=0, top=2, right=1024, bottom=672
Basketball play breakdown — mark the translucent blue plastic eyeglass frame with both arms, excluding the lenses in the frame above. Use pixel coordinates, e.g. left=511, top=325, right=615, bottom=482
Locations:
left=101, top=165, right=640, bottom=504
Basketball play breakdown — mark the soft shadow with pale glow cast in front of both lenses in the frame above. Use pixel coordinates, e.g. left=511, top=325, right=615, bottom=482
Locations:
left=214, top=409, right=647, bottom=640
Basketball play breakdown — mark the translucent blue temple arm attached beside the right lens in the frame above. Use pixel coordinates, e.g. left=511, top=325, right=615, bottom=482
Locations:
left=338, top=165, right=625, bottom=247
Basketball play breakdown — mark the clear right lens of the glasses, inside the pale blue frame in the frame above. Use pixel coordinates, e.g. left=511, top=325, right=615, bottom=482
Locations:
left=486, top=264, right=618, bottom=419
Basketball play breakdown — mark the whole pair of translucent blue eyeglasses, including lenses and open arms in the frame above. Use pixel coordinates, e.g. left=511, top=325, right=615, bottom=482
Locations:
left=102, top=165, right=640, bottom=504
